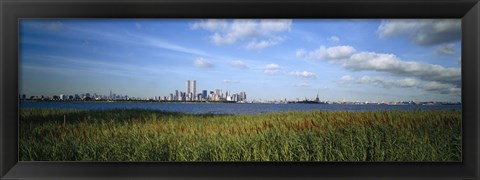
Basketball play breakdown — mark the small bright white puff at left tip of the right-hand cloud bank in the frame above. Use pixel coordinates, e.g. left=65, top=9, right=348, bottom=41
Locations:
left=308, top=46, right=356, bottom=59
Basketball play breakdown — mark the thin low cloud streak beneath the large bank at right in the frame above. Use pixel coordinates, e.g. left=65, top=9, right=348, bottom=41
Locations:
left=356, top=76, right=461, bottom=94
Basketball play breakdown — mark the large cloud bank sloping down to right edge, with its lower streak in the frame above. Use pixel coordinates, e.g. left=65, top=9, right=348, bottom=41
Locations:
left=297, top=46, right=461, bottom=93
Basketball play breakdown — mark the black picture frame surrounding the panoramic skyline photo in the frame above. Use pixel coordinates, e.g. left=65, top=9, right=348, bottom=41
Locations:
left=0, top=0, right=480, bottom=180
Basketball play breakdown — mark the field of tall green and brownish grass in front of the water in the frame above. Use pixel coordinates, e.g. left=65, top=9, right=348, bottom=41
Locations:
left=19, top=109, right=462, bottom=161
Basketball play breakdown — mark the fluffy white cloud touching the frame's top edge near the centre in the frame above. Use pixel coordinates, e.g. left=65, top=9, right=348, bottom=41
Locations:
left=191, top=19, right=292, bottom=49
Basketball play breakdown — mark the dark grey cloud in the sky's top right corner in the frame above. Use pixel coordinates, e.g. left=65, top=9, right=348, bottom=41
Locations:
left=377, top=19, right=461, bottom=46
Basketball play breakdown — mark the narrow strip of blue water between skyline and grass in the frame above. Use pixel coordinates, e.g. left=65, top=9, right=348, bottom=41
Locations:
left=20, top=102, right=461, bottom=114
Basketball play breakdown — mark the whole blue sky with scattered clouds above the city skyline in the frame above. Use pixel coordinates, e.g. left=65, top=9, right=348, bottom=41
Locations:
left=20, top=19, right=461, bottom=102
